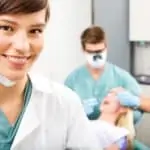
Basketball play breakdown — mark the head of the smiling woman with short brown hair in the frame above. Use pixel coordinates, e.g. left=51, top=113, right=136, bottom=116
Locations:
left=0, top=0, right=49, bottom=85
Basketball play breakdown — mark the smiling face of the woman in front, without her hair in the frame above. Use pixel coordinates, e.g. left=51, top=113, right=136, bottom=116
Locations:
left=0, top=9, right=46, bottom=80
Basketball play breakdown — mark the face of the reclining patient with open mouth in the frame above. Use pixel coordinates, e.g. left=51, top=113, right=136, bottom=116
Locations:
left=100, top=92, right=122, bottom=113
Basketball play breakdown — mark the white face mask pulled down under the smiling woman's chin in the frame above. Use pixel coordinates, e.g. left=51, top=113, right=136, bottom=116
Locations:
left=0, top=74, right=16, bottom=87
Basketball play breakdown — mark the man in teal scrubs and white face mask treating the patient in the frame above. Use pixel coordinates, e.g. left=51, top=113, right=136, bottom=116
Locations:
left=65, top=26, right=150, bottom=148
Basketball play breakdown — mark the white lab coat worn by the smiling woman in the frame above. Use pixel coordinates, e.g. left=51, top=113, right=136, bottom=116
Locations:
left=11, top=75, right=101, bottom=150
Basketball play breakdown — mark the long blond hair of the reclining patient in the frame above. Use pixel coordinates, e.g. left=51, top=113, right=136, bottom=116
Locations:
left=116, top=108, right=135, bottom=150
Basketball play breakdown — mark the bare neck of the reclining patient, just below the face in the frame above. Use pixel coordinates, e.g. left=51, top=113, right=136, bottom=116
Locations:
left=99, top=113, right=118, bottom=125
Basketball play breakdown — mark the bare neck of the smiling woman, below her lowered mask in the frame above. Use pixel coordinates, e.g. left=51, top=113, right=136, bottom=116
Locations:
left=0, top=76, right=27, bottom=104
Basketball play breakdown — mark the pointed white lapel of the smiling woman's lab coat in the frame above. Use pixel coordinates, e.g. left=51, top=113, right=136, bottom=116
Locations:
left=11, top=93, right=40, bottom=149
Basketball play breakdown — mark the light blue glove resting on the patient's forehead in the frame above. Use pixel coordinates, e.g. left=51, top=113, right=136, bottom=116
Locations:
left=117, top=91, right=140, bottom=108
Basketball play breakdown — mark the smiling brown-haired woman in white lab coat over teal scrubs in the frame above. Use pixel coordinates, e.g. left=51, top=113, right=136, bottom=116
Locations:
left=0, top=0, right=101, bottom=150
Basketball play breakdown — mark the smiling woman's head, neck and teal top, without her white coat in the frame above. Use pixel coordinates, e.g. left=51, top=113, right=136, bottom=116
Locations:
left=0, top=0, right=49, bottom=146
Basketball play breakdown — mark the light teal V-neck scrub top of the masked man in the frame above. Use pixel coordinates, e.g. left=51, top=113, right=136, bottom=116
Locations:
left=65, top=62, right=142, bottom=123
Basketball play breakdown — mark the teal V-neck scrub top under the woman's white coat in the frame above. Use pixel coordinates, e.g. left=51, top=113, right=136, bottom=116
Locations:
left=0, top=80, right=32, bottom=150
